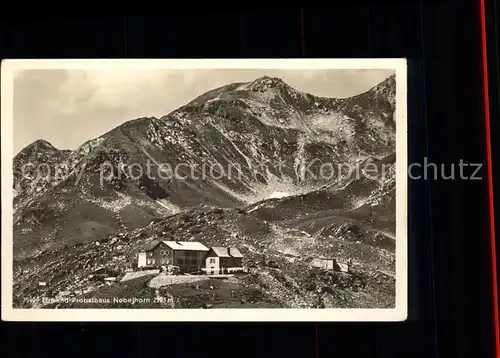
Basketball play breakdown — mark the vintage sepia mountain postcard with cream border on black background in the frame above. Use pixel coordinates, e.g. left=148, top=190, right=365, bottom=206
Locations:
left=1, top=59, right=408, bottom=322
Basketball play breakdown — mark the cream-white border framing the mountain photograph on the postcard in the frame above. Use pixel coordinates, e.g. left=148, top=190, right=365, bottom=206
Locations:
left=1, top=59, right=408, bottom=322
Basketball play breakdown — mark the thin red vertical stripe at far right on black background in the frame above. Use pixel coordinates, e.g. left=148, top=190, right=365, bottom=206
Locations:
left=481, top=0, right=500, bottom=358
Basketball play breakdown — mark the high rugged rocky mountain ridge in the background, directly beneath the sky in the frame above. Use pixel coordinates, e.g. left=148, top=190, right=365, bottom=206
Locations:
left=14, top=76, right=395, bottom=258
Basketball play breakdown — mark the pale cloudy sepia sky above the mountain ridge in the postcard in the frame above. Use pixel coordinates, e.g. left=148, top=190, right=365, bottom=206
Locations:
left=14, top=69, right=394, bottom=153
